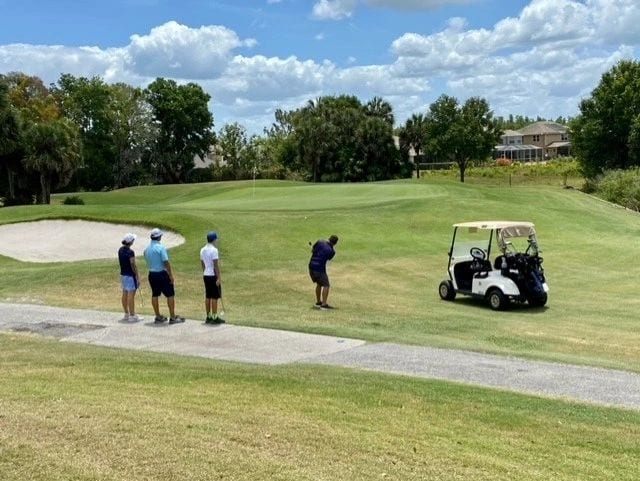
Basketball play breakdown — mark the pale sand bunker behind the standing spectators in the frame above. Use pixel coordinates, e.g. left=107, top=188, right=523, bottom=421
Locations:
left=0, top=220, right=184, bottom=262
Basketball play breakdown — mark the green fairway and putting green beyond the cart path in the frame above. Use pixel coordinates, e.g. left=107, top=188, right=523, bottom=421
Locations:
left=0, top=176, right=640, bottom=371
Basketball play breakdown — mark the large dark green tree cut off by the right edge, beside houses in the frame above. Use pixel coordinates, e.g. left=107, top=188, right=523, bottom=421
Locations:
left=570, top=60, right=640, bottom=177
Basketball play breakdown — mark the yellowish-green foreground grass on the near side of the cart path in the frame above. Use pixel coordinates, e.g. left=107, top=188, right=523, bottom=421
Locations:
left=0, top=334, right=640, bottom=481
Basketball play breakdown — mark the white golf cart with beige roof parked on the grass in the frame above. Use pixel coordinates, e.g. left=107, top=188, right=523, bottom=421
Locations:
left=439, top=221, right=549, bottom=310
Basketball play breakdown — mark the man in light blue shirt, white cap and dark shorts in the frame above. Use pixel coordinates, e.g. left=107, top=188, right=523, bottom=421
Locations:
left=144, top=228, right=184, bottom=324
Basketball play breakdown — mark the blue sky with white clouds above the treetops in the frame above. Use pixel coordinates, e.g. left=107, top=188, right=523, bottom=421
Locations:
left=0, top=0, right=640, bottom=133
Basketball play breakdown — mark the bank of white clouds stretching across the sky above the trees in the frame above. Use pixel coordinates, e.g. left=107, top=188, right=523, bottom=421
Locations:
left=0, top=0, right=640, bottom=132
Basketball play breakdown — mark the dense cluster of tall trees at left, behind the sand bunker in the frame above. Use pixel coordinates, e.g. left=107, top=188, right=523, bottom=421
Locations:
left=0, top=73, right=215, bottom=204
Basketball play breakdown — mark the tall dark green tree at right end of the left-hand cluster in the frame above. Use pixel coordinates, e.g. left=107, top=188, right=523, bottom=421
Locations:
left=147, top=78, right=215, bottom=183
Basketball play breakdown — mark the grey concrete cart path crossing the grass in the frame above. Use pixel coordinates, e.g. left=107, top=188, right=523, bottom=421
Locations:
left=0, top=303, right=640, bottom=410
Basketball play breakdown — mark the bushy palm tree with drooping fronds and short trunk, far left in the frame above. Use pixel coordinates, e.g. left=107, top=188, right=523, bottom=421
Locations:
left=25, top=118, right=81, bottom=204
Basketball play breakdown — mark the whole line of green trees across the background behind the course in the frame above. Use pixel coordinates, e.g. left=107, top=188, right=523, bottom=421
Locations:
left=5, top=60, right=640, bottom=204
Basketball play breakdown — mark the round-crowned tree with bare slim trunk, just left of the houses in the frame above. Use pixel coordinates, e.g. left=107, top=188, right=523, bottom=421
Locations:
left=427, top=95, right=501, bottom=182
